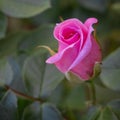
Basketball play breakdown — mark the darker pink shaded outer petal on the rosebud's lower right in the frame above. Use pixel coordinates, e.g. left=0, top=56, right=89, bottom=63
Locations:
left=71, top=38, right=102, bottom=80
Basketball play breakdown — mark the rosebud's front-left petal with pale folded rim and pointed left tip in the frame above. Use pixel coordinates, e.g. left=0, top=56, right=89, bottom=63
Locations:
left=46, top=42, right=80, bottom=73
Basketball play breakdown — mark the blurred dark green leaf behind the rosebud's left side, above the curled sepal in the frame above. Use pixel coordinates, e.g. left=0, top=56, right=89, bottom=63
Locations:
left=18, top=24, right=57, bottom=53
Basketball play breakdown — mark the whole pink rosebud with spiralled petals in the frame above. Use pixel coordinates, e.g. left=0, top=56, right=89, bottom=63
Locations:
left=46, top=18, right=101, bottom=80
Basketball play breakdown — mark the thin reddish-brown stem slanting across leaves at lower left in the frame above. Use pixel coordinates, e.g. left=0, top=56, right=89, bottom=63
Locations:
left=5, top=85, right=45, bottom=103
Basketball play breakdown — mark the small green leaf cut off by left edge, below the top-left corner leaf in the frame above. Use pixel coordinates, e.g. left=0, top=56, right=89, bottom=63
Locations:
left=0, top=12, right=7, bottom=39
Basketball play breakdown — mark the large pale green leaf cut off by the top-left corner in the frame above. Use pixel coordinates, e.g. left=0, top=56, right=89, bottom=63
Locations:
left=0, top=0, right=50, bottom=18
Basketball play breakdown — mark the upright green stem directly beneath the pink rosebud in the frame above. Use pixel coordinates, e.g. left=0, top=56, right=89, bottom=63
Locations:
left=90, top=80, right=96, bottom=105
